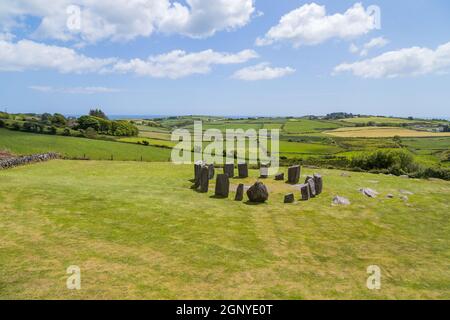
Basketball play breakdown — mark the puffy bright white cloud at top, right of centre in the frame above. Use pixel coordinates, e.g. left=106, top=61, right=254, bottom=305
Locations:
left=256, top=3, right=376, bottom=47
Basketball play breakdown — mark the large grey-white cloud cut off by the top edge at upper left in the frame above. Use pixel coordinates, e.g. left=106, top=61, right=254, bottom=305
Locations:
left=0, top=0, right=255, bottom=43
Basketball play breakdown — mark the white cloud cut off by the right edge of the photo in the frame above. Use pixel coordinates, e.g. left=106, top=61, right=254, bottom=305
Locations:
left=334, top=42, right=450, bottom=79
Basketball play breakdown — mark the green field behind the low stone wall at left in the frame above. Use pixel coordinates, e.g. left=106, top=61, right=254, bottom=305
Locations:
left=0, top=129, right=170, bottom=161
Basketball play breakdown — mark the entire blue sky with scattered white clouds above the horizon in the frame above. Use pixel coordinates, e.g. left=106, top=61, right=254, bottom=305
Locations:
left=0, top=0, right=450, bottom=118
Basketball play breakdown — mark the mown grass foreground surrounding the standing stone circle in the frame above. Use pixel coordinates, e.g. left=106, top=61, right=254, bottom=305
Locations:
left=0, top=161, right=450, bottom=299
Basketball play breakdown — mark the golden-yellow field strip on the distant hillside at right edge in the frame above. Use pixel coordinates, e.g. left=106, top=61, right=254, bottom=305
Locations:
left=325, top=127, right=450, bottom=138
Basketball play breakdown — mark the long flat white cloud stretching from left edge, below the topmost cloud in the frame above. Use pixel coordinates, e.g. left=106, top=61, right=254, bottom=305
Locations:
left=0, top=40, right=258, bottom=79
